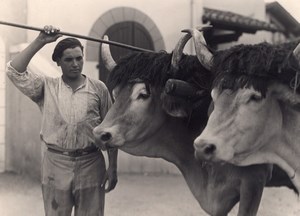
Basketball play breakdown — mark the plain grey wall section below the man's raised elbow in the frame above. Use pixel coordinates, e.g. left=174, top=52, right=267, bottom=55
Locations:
left=6, top=77, right=41, bottom=178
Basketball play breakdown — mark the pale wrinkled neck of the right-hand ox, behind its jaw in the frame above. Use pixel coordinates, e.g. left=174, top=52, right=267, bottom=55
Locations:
left=241, top=105, right=300, bottom=191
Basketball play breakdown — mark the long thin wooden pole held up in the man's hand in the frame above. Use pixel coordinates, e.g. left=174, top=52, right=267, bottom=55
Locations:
left=0, top=21, right=154, bottom=52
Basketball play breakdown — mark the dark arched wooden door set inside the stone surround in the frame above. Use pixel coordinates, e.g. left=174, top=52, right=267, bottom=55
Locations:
left=99, top=21, right=154, bottom=82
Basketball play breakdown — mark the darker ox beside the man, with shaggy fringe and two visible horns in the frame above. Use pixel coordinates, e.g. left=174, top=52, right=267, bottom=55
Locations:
left=94, top=32, right=292, bottom=216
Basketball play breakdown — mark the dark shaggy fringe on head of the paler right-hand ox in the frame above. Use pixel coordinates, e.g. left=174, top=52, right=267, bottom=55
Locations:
left=212, top=43, right=300, bottom=95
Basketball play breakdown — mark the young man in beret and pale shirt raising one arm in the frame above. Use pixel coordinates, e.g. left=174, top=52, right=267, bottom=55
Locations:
left=7, top=26, right=117, bottom=216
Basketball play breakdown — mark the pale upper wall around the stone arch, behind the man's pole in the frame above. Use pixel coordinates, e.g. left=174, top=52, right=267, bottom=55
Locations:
left=28, top=0, right=202, bottom=57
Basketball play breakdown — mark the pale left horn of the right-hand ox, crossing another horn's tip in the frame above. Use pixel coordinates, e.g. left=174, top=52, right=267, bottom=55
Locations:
left=183, top=26, right=213, bottom=70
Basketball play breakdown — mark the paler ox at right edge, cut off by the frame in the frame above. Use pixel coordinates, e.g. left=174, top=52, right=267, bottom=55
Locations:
left=194, top=31, right=300, bottom=191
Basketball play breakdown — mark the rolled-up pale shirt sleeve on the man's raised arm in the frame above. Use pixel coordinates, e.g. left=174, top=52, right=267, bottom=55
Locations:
left=6, top=62, right=45, bottom=103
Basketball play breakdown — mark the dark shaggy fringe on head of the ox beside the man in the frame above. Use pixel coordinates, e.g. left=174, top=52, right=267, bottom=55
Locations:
left=108, top=52, right=212, bottom=93
